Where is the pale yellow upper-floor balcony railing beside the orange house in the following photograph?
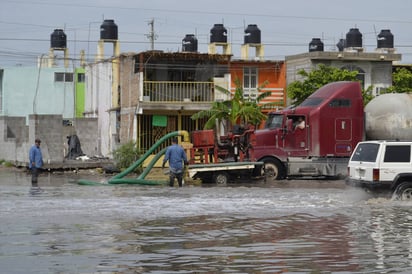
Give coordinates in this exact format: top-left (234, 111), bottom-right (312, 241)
top-left (143, 81), bottom-right (214, 103)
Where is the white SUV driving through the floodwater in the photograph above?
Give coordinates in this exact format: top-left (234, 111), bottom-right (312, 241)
top-left (347, 141), bottom-right (412, 200)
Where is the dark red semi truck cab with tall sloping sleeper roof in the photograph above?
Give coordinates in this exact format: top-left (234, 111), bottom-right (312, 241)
top-left (253, 81), bottom-right (364, 179)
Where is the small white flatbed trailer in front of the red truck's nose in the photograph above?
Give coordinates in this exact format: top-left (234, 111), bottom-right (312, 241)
top-left (187, 162), bottom-right (264, 185)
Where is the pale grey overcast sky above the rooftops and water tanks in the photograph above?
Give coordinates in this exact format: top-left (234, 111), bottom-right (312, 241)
top-left (0, 0), bottom-right (412, 67)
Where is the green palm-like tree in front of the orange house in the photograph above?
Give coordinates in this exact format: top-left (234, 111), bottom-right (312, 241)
top-left (191, 79), bottom-right (280, 129)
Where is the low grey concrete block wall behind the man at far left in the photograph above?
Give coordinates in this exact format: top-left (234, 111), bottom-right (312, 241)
top-left (0, 115), bottom-right (102, 167)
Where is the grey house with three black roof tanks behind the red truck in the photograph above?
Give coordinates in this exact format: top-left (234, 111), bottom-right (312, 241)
top-left (285, 28), bottom-right (401, 95)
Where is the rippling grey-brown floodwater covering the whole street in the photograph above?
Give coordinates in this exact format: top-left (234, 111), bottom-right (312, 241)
top-left (0, 170), bottom-right (412, 273)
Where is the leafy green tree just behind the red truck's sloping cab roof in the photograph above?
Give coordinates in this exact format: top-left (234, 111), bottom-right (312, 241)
top-left (287, 64), bottom-right (362, 105)
